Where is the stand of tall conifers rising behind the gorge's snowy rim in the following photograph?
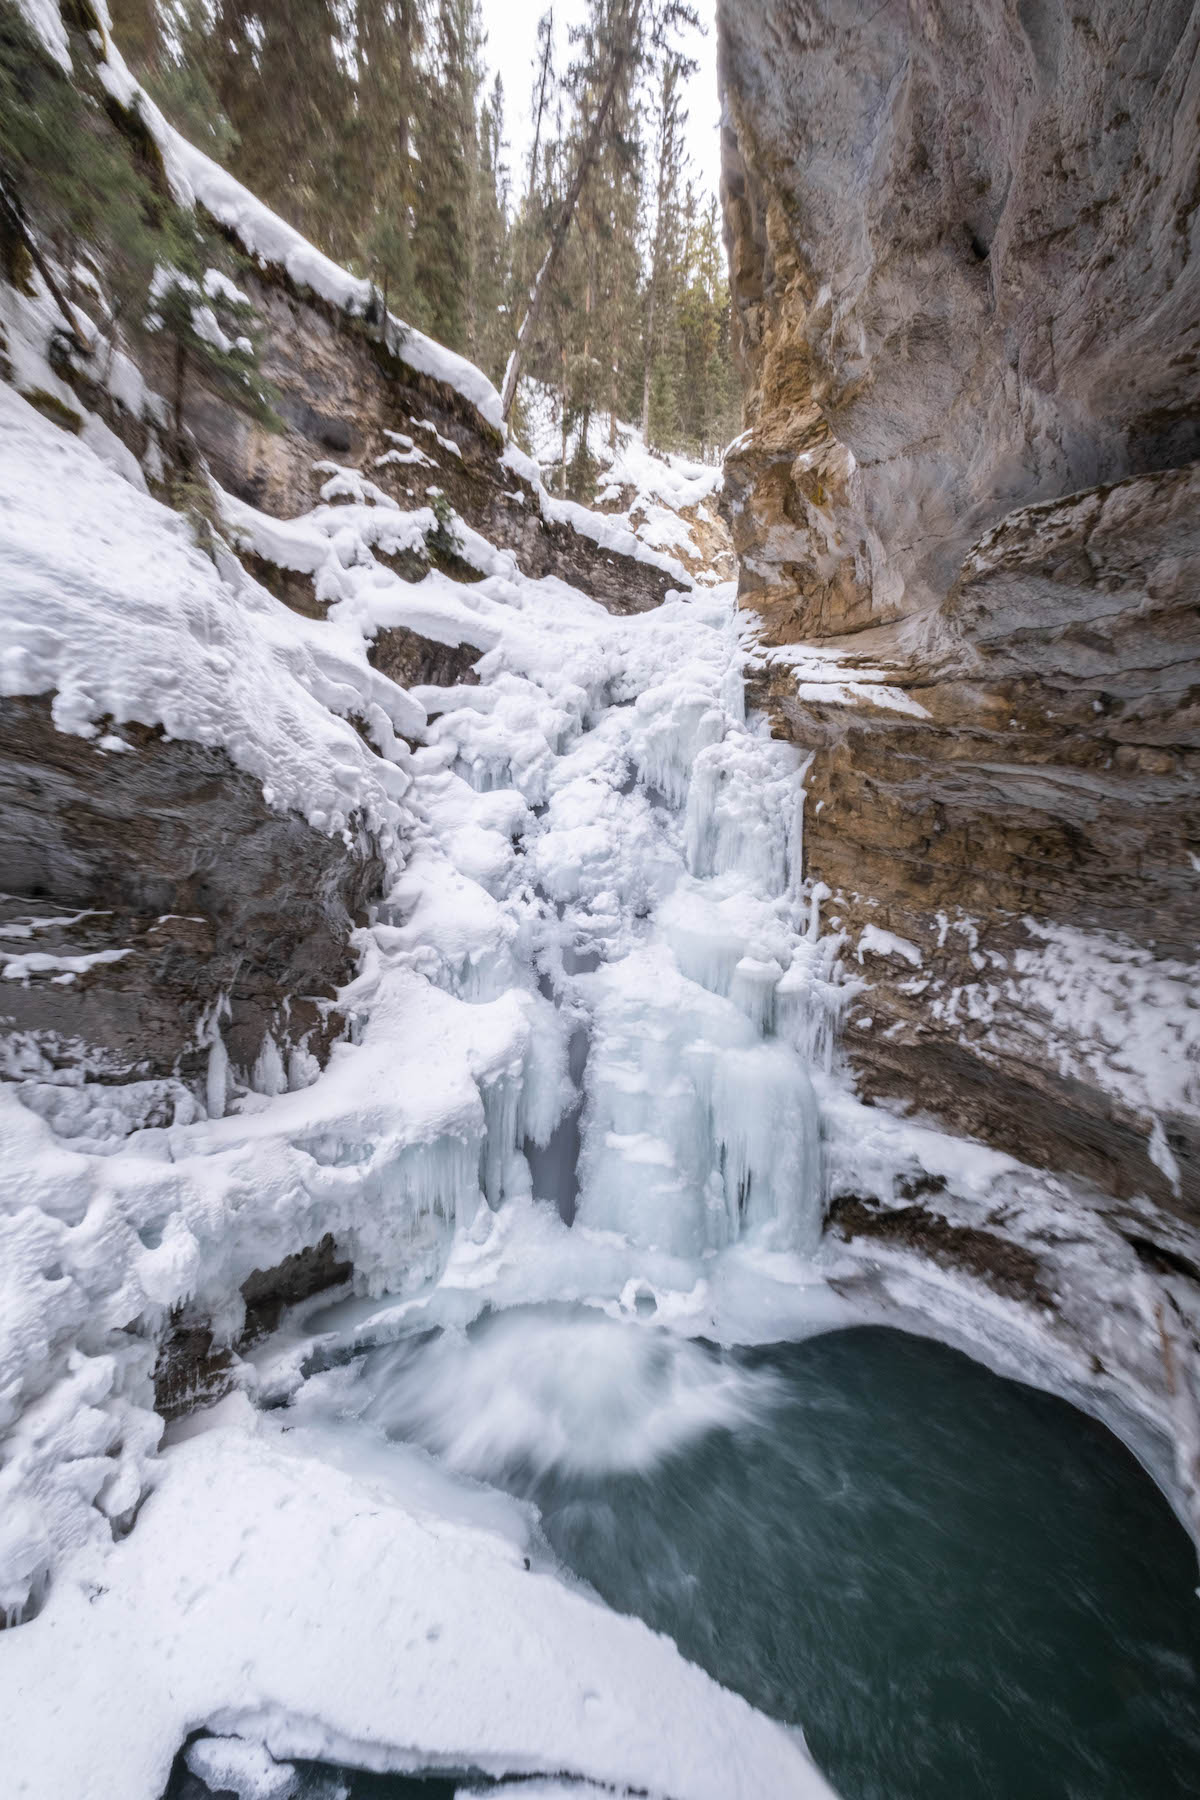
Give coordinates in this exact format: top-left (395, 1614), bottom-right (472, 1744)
top-left (98, 0), bottom-right (739, 471)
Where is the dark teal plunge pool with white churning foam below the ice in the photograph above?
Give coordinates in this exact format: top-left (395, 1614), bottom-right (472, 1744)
top-left (287, 1309), bottom-right (1200, 1800)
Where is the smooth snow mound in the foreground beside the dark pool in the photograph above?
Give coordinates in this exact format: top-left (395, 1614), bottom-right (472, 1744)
top-left (0, 1415), bottom-right (829, 1800)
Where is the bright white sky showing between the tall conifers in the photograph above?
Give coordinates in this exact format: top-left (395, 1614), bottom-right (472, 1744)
top-left (480, 0), bottom-right (721, 194)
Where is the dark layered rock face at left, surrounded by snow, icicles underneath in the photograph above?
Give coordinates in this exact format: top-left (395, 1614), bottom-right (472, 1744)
top-left (0, 698), bottom-right (381, 1136)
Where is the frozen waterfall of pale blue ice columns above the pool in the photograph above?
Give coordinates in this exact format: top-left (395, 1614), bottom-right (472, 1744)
top-left (415, 589), bottom-right (838, 1258)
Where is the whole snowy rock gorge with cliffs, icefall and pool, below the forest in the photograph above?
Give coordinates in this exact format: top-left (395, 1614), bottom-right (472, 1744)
top-left (0, 0), bottom-right (1200, 1800)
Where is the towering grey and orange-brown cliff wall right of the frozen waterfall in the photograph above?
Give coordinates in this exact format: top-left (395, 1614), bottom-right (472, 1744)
top-left (718, 0), bottom-right (1200, 1244)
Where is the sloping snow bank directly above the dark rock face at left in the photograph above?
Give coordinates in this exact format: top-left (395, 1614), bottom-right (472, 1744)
top-left (0, 385), bottom-right (425, 862)
